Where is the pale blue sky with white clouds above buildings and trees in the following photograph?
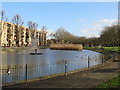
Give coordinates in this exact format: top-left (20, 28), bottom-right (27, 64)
top-left (1, 2), bottom-right (118, 37)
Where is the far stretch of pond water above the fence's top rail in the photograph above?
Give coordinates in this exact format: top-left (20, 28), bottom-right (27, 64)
top-left (2, 49), bottom-right (102, 65)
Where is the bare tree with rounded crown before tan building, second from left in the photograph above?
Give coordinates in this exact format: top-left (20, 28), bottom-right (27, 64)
top-left (12, 14), bottom-right (24, 47)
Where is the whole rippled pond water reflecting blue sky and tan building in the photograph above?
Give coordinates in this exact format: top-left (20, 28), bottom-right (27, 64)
top-left (1, 49), bottom-right (103, 84)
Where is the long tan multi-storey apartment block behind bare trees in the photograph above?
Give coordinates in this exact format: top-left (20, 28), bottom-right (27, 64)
top-left (0, 21), bottom-right (47, 46)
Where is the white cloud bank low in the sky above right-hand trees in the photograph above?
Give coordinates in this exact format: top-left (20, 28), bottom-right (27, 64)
top-left (81, 19), bottom-right (117, 38)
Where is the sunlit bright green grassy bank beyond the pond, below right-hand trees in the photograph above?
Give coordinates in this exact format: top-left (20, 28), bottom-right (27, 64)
top-left (84, 47), bottom-right (120, 52)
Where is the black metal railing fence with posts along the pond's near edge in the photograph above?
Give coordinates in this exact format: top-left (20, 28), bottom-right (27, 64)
top-left (0, 56), bottom-right (109, 86)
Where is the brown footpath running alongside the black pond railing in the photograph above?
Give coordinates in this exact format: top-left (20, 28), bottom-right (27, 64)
top-left (5, 61), bottom-right (120, 88)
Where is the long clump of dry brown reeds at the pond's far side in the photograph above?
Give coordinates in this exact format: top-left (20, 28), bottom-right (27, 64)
top-left (50, 44), bottom-right (83, 51)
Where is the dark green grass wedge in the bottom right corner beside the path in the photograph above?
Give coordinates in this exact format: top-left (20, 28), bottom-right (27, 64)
top-left (97, 76), bottom-right (120, 88)
